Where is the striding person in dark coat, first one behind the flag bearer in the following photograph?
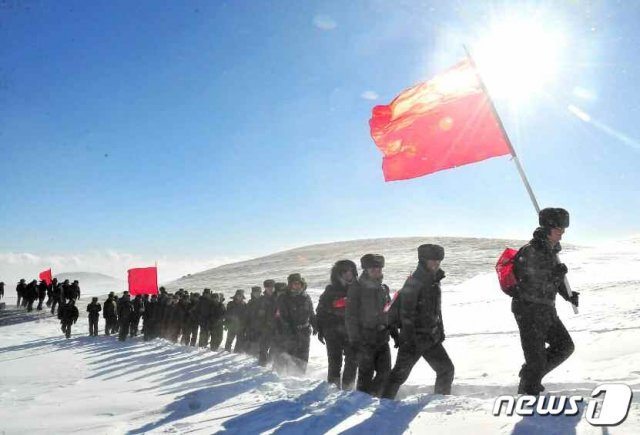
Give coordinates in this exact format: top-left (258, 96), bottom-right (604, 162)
top-left (382, 244), bottom-right (455, 399)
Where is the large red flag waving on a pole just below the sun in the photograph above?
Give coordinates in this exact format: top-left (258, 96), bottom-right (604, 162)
top-left (369, 59), bottom-right (510, 181)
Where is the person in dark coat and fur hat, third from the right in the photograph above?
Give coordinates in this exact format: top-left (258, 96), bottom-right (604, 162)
top-left (345, 254), bottom-right (391, 397)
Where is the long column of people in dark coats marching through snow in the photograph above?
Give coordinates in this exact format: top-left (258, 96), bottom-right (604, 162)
top-left (6, 208), bottom-right (578, 399)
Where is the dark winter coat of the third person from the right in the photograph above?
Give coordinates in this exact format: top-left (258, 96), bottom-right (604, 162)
top-left (345, 271), bottom-right (391, 344)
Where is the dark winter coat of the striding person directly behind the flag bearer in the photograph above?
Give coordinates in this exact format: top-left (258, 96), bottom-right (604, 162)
top-left (396, 263), bottom-right (444, 348)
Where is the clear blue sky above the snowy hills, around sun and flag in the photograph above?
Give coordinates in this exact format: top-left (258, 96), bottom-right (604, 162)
top-left (0, 0), bottom-right (640, 278)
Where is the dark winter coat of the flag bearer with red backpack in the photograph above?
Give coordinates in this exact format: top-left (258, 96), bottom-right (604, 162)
top-left (513, 228), bottom-right (568, 306)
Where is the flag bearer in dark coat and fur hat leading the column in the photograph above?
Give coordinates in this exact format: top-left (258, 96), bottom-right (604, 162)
top-left (511, 208), bottom-right (578, 395)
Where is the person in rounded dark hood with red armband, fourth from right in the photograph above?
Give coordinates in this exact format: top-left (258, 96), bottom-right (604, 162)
top-left (316, 260), bottom-right (358, 390)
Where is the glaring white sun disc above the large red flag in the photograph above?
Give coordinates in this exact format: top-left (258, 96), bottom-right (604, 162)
top-left (472, 18), bottom-right (564, 102)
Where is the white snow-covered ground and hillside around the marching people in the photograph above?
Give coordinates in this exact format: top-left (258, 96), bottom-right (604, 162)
top-left (0, 239), bottom-right (640, 434)
